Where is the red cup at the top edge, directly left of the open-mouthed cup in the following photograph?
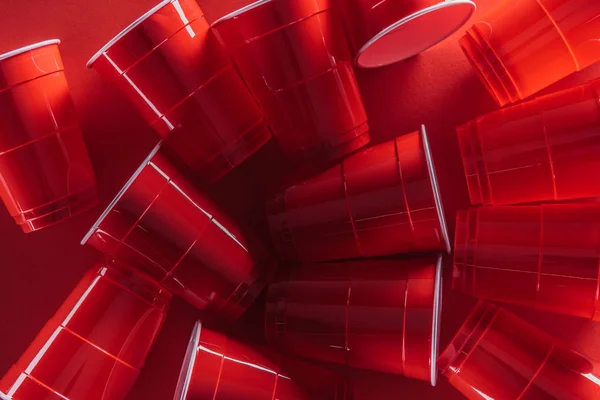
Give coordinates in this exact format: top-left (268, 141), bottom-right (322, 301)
top-left (213, 0), bottom-right (370, 165)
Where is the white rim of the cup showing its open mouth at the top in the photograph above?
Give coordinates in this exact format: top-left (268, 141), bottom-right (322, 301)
top-left (354, 0), bottom-right (477, 68)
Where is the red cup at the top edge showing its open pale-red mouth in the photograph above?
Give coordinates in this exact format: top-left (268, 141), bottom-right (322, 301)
top-left (340, 0), bottom-right (475, 68)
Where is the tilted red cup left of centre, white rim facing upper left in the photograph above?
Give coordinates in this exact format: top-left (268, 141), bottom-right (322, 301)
top-left (81, 144), bottom-right (275, 319)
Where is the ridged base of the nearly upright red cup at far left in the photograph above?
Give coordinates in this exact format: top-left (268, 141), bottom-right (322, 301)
top-left (15, 186), bottom-right (98, 233)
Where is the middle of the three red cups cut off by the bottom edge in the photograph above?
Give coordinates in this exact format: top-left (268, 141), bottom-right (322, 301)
top-left (173, 322), bottom-right (354, 400)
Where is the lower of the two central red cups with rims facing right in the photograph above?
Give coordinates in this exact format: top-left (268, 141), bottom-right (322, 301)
top-left (265, 256), bottom-right (442, 386)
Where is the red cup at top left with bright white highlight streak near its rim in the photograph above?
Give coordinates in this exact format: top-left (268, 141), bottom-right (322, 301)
top-left (88, 0), bottom-right (271, 181)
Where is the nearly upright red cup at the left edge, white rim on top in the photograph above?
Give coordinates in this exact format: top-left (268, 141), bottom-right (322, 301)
top-left (0, 39), bottom-right (97, 233)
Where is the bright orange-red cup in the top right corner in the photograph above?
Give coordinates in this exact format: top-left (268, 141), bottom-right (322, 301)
top-left (459, 0), bottom-right (600, 106)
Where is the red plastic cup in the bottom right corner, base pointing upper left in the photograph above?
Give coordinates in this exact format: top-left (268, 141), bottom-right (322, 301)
top-left (439, 301), bottom-right (600, 400)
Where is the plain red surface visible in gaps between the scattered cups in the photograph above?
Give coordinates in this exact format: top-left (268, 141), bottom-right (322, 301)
top-left (0, 0), bottom-right (600, 400)
